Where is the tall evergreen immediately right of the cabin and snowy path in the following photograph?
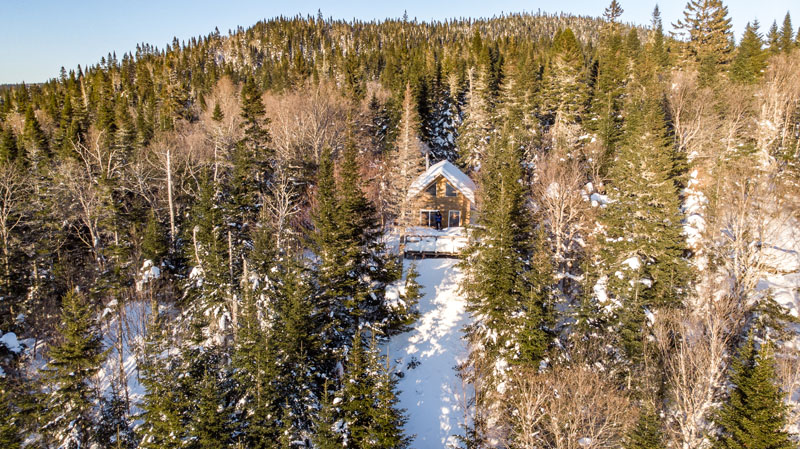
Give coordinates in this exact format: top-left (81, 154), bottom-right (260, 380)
top-left (463, 120), bottom-right (552, 372)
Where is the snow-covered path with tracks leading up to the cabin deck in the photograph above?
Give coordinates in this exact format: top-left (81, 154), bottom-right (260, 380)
top-left (387, 259), bottom-right (469, 449)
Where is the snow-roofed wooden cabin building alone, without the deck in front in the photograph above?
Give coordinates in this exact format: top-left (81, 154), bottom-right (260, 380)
top-left (408, 161), bottom-right (476, 228)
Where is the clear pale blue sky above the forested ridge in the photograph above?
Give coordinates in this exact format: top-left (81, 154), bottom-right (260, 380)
top-left (0, 0), bottom-right (800, 84)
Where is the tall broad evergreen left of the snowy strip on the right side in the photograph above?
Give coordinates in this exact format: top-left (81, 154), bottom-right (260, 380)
top-left (601, 54), bottom-right (689, 372)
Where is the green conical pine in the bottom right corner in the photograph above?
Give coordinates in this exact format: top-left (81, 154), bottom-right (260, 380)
top-left (714, 336), bottom-right (797, 449)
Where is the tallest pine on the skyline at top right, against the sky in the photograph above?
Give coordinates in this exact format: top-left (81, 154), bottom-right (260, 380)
top-left (675, 0), bottom-right (733, 85)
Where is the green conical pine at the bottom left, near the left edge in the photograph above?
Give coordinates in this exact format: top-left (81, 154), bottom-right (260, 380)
top-left (44, 290), bottom-right (105, 447)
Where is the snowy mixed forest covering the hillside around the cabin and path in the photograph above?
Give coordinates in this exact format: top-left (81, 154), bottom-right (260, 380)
top-left (0, 0), bottom-right (800, 449)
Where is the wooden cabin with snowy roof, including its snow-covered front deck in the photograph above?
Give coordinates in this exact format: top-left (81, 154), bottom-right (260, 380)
top-left (400, 161), bottom-right (476, 257)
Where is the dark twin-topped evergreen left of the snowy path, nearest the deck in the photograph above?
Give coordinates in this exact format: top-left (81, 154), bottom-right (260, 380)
top-left (314, 141), bottom-right (400, 368)
